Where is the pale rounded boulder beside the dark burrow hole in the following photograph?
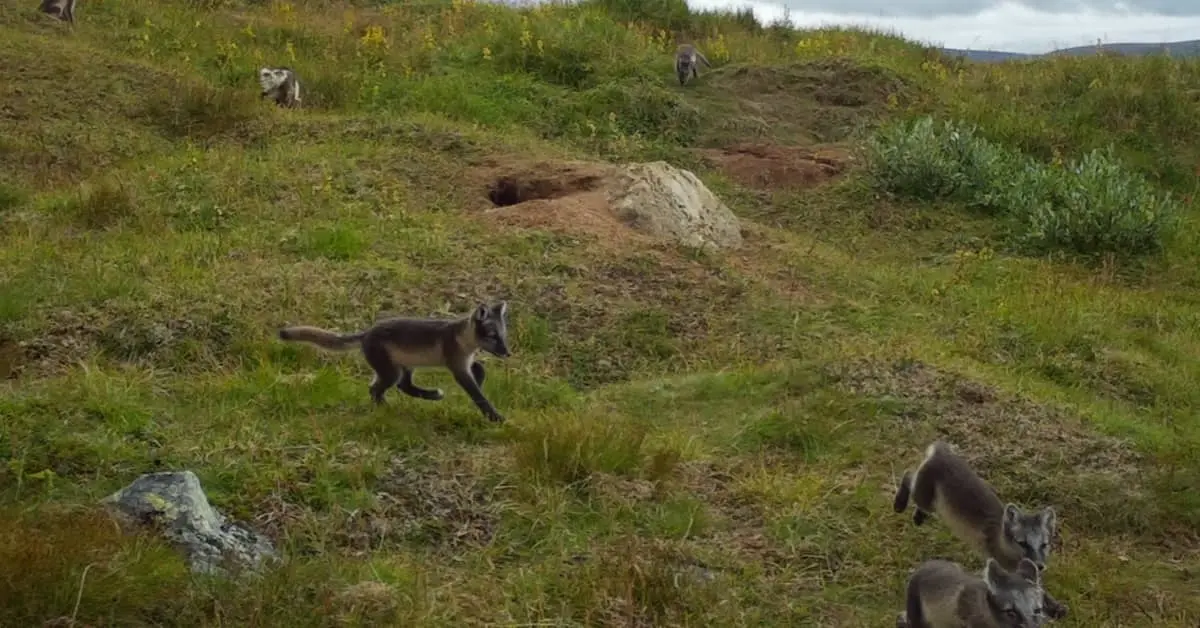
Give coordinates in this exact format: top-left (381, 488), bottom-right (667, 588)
top-left (608, 161), bottom-right (742, 249)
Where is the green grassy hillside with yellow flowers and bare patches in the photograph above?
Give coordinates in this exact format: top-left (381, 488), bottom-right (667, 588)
top-left (0, 0), bottom-right (1200, 627)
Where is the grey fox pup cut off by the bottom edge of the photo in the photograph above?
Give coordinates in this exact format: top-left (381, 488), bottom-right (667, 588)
top-left (896, 558), bottom-right (1046, 628)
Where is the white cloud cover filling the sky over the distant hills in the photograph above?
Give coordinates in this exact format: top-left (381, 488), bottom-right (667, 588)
top-left (688, 0), bottom-right (1200, 53)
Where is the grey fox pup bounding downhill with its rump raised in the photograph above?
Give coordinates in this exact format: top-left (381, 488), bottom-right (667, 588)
top-left (892, 441), bottom-right (1067, 618)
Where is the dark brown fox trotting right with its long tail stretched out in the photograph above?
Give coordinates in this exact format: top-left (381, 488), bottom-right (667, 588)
top-left (280, 301), bottom-right (511, 423)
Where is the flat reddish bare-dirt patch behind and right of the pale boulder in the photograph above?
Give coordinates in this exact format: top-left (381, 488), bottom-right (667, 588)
top-left (696, 143), bottom-right (853, 189)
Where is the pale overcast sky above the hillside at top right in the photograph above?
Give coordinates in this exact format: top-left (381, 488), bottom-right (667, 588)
top-left (688, 0), bottom-right (1200, 53)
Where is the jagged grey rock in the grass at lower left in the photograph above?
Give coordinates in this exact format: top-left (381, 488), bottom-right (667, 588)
top-left (102, 471), bottom-right (277, 574)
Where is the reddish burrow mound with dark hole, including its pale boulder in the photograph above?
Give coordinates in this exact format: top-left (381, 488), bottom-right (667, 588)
top-left (484, 162), bottom-right (742, 249)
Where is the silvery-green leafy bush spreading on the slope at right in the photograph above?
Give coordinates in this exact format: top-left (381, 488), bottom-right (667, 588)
top-left (865, 116), bottom-right (1181, 255)
